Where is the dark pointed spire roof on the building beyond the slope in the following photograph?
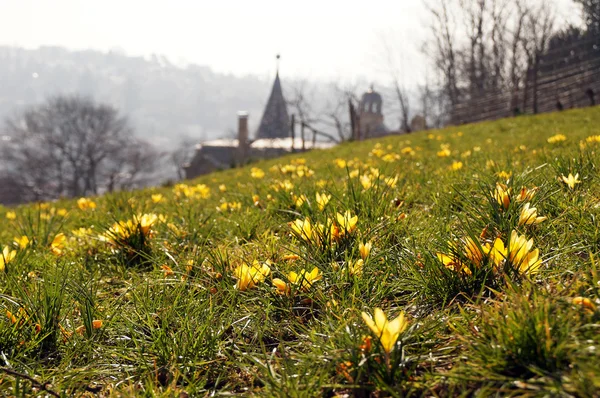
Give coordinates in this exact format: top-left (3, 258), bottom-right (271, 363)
top-left (256, 71), bottom-right (290, 139)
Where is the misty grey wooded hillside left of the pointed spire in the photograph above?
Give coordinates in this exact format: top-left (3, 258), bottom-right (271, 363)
top-left (0, 46), bottom-right (272, 147)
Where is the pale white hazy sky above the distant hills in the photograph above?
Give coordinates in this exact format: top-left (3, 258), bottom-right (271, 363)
top-left (0, 0), bottom-right (577, 84)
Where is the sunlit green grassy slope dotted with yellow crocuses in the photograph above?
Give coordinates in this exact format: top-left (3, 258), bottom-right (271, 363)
top-left (0, 107), bottom-right (600, 397)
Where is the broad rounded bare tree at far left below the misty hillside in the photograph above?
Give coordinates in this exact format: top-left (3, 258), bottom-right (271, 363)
top-left (2, 96), bottom-right (156, 200)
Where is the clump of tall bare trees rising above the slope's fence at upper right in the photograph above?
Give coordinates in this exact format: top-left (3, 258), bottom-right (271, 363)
top-left (425, 0), bottom-right (560, 121)
